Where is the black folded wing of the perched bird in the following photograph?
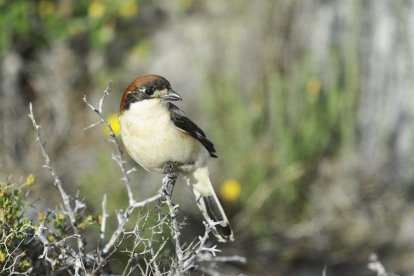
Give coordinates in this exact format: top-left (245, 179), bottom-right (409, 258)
top-left (168, 103), bottom-right (217, 158)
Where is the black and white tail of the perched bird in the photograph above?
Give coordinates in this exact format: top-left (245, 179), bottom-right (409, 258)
top-left (186, 167), bottom-right (234, 242)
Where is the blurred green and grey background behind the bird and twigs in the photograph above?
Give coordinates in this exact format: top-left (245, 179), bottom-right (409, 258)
top-left (0, 0), bottom-right (414, 275)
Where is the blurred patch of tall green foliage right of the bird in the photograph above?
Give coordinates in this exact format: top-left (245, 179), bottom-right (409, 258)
top-left (203, 53), bottom-right (358, 236)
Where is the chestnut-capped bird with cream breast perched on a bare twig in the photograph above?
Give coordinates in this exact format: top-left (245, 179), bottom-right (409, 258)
top-left (119, 74), bottom-right (234, 242)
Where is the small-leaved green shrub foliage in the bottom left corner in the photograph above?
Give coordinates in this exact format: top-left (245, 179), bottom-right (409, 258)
top-left (0, 177), bottom-right (99, 275)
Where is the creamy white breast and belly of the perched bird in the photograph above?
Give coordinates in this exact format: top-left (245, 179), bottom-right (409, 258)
top-left (119, 99), bottom-right (208, 171)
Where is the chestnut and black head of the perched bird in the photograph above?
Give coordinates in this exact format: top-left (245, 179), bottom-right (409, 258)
top-left (119, 75), bottom-right (182, 113)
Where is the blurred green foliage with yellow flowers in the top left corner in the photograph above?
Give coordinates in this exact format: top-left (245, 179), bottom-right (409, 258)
top-left (0, 0), bottom-right (145, 56)
